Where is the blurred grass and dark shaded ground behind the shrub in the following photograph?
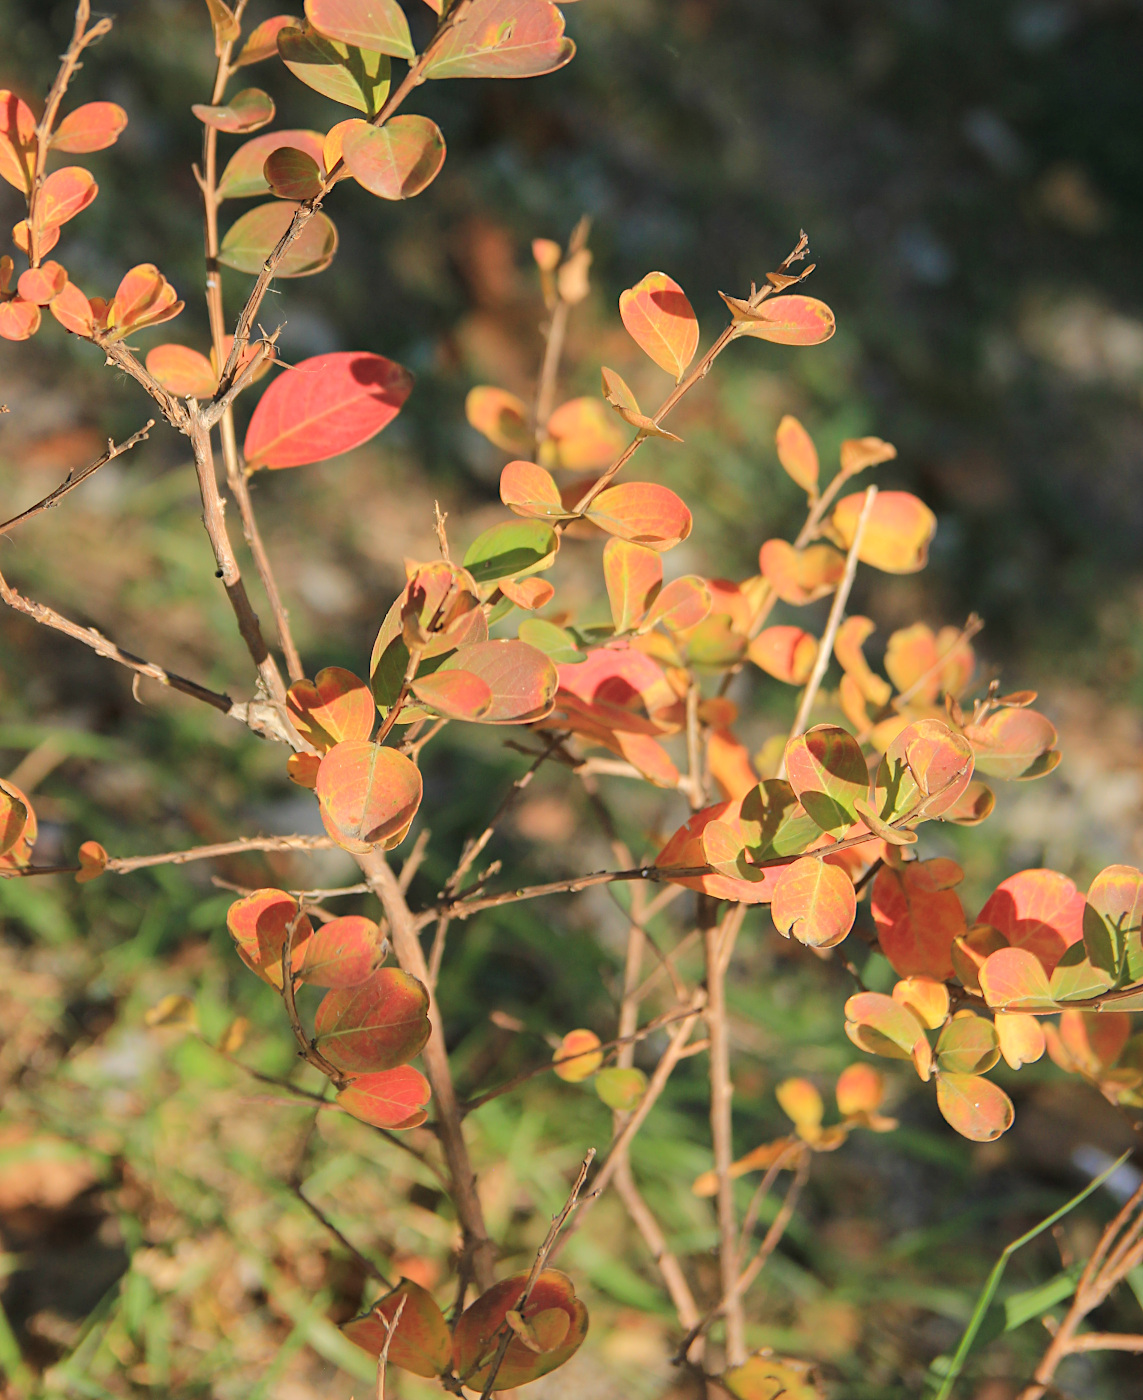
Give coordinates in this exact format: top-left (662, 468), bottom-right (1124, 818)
top-left (0, 0), bottom-right (1143, 1400)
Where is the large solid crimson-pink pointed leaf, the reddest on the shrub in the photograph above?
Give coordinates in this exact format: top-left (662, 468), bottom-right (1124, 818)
top-left (244, 350), bottom-right (413, 470)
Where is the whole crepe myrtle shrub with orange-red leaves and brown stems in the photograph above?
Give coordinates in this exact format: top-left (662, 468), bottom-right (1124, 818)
top-left (0, 0), bottom-right (1143, 1400)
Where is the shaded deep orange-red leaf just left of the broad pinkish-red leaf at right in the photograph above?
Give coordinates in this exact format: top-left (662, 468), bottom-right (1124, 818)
top-left (870, 861), bottom-right (965, 981)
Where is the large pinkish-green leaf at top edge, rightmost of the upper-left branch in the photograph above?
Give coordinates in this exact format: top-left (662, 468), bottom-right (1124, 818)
top-left (424, 0), bottom-right (576, 81)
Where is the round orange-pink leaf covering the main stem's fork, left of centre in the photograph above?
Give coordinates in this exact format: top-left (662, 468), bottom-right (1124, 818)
top-left (315, 739), bottom-right (422, 855)
